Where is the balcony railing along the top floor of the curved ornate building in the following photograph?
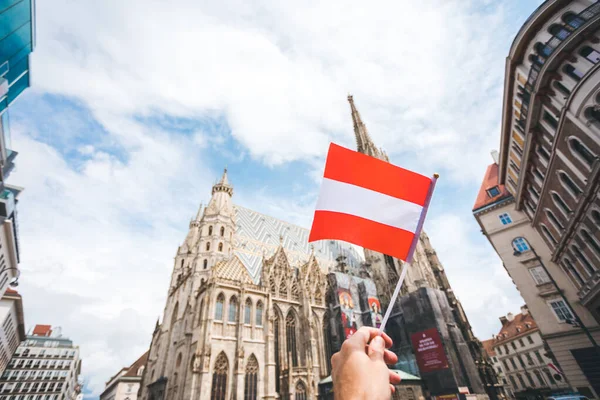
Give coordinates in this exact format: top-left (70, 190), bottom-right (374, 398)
top-left (517, 1), bottom-right (600, 134)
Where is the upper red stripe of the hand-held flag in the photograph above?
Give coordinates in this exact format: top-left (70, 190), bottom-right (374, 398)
top-left (324, 143), bottom-right (431, 206)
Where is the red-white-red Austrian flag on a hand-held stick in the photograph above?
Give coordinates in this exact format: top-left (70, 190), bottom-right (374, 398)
top-left (308, 143), bottom-right (435, 262)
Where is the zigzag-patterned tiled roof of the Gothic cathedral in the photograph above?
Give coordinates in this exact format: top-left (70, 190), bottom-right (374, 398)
top-left (233, 205), bottom-right (364, 283)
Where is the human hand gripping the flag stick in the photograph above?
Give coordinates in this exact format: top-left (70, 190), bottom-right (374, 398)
top-left (331, 326), bottom-right (400, 400)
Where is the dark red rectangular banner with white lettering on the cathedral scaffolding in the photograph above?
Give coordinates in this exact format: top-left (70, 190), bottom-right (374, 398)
top-left (410, 328), bottom-right (448, 373)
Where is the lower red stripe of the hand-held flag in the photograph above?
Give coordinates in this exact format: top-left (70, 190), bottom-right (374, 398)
top-left (308, 211), bottom-right (415, 260)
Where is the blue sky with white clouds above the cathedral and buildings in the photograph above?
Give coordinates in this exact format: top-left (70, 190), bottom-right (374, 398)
top-left (10, 0), bottom-right (540, 398)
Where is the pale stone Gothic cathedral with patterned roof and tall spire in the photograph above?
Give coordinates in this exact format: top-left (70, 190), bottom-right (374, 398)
top-left (140, 96), bottom-right (492, 400)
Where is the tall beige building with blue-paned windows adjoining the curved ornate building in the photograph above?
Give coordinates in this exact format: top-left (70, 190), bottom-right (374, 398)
top-left (473, 158), bottom-right (600, 397)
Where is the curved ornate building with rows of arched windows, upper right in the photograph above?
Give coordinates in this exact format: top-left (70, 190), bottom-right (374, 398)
top-left (499, 0), bottom-right (600, 321)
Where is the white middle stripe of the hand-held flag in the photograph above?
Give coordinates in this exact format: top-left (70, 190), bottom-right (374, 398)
top-left (316, 178), bottom-right (423, 232)
